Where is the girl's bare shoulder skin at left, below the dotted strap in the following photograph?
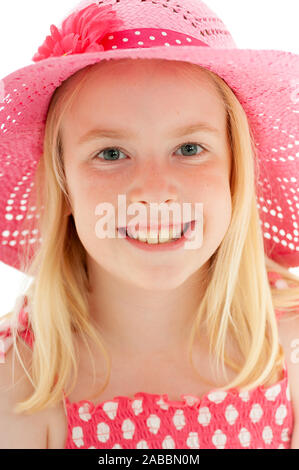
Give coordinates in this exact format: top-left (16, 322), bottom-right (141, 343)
top-left (0, 339), bottom-right (49, 449)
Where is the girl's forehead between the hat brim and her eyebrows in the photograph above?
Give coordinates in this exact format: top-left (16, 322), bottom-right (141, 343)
top-left (64, 60), bottom-right (226, 133)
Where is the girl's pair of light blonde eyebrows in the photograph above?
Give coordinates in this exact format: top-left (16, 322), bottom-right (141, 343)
top-left (78, 122), bottom-right (220, 144)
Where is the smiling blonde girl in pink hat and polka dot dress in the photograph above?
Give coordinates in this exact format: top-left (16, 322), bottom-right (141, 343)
top-left (0, 0), bottom-right (299, 449)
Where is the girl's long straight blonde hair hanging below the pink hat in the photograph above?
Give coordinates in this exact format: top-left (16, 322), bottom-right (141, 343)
top-left (4, 59), bottom-right (299, 414)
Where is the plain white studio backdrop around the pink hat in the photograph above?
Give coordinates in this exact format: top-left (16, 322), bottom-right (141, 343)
top-left (0, 0), bottom-right (299, 317)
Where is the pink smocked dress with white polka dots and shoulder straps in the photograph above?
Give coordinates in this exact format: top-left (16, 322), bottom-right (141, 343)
top-left (0, 273), bottom-right (294, 449)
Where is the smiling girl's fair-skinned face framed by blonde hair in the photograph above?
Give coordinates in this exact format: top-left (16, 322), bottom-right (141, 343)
top-left (62, 61), bottom-right (231, 289)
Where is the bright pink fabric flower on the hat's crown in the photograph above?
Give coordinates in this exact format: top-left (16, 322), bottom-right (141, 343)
top-left (32, 3), bottom-right (123, 62)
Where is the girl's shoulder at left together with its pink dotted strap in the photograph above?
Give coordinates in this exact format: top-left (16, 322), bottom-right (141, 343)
top-left (0, 302), bottom-right (55, 449)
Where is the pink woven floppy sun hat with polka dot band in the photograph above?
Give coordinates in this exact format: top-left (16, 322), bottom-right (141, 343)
top-left (0, 0), bottom-right (299, 270)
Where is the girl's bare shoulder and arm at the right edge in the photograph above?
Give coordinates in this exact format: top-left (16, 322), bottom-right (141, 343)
top-left (278, 313), bottom-right (299, 449)
